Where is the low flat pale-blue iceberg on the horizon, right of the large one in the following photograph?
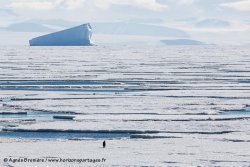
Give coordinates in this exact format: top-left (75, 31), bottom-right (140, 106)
top-left (161, 39), bottom-right (205, 45)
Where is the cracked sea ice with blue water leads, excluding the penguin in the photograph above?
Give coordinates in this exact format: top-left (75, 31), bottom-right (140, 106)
top-left (0, 45), bottom-right (250, 167)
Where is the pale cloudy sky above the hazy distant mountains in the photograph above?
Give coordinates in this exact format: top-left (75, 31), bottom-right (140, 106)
top-left (0, 0), bottom-right (250, 44)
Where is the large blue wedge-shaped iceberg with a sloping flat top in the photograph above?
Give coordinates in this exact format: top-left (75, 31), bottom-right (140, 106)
top-left (29, 23), bottom-right (92, 46)
